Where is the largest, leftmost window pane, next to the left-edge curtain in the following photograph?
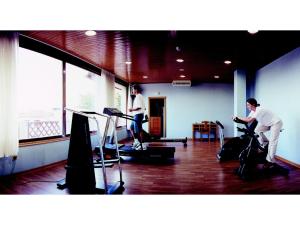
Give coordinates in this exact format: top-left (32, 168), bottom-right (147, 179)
top-left (18, 48), bottom-right (62, 139)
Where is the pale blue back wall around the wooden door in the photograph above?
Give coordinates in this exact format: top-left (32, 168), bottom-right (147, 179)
top-left (142, 83), bottom-right (234, 138)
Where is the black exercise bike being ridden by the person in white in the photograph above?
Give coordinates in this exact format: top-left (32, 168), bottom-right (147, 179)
top-left (234, 118), bottom-right (289, 180)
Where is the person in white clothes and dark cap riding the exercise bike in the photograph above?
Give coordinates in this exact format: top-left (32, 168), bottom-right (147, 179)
top-left (233, 98), bottom-right (283, 168)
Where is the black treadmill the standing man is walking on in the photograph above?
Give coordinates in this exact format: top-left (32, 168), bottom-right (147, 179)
top-left (97, 108), bottom-right (176, 159)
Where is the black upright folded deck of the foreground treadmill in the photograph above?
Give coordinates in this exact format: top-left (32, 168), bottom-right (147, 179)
top-left (66, 113), bottom-right (96, 194)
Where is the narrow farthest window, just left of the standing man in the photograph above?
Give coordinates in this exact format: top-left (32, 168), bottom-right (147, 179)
top-left (114, 83), bottom-right (127, 127)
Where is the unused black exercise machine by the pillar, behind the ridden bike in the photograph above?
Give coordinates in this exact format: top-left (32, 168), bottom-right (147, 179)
top-left (216, 120), bottom-right (257, 162)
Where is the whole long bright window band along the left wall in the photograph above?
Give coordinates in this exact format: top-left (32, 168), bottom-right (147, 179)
top-left (17, 44), bottom-right (127, 140)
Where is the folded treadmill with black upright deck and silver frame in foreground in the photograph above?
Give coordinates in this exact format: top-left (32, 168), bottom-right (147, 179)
top-left (57, 109), bottom-right (124, 194)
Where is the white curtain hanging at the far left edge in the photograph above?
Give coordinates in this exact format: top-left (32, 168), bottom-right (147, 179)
top-left (0, 32), bottom-right (19, 158)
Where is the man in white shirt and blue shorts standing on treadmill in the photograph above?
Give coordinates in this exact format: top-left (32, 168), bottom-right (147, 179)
top-left (128, 85), bottom-right (146, 150)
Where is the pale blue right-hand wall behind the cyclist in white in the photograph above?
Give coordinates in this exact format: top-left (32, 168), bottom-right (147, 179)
top-left (254, 48), bottom-right (300, 164)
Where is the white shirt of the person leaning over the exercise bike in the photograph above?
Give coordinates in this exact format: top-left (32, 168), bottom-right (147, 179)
top-left (248, 106), bottom-right (281, 127)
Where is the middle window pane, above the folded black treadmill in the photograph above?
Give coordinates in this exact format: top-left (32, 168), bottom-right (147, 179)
top-left (66, 63), bottom-right (102, 134)
